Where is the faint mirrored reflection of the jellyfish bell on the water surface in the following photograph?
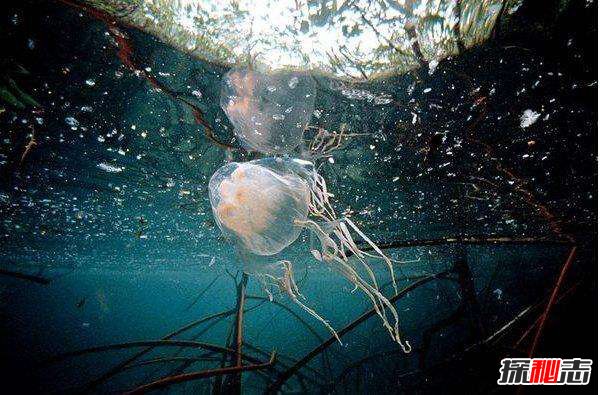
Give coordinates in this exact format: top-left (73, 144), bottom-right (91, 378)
top-left (221, 69), bottom-right (315, 154)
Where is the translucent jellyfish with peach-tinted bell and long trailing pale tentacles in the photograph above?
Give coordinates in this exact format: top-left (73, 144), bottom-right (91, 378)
top-left (209, 158), bottom-right (410, 352)
